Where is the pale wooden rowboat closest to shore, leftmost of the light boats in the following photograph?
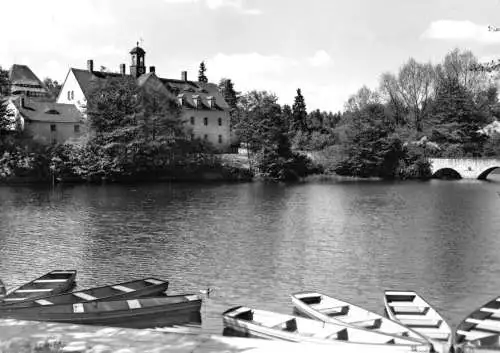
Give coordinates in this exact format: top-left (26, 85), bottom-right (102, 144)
top-left (223, 306), bottom-right (431, 352)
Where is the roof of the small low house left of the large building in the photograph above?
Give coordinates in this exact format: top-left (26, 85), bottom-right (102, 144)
top-left (12, 97), bottom-right (83, 123)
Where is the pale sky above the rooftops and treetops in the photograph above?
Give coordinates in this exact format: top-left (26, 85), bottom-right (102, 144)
top-left (4, 0), bottom-right (500, 112)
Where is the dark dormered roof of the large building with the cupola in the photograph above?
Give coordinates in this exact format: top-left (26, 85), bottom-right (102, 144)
top-left (70, 68), bottom-right (229, 110)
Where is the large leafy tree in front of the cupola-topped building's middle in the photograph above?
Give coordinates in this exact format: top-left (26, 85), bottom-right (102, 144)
top-left (83, 76), bottom-right (188, 177)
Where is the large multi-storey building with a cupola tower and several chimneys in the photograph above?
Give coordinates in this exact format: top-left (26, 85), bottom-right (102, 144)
top-left (57, 46), bottom-right (231, 151)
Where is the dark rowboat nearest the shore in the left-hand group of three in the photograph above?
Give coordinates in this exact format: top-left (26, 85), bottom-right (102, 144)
top-left (0, 294), bottom-right (202, 328)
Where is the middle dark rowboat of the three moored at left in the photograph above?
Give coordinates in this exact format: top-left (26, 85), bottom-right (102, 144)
top-left (0, 278), bottom-right (168, 310)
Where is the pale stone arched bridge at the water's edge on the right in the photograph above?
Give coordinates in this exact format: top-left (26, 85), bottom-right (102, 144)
top-left (429, 158), bottom-right (500, 179)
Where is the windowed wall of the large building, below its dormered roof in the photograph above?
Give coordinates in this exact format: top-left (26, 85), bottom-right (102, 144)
top-left (182, 109), bottom-right (231, 151)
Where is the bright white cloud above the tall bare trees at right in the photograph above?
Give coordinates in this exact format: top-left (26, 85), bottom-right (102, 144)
top-left (421, 20), bottom-right (500, 44)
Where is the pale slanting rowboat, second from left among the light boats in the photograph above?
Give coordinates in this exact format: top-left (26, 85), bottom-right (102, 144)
top-left (291, 292), bottom-right (428, 343)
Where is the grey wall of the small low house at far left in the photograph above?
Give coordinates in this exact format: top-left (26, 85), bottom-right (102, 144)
top-left (25, 121), bottom-right (86, 144)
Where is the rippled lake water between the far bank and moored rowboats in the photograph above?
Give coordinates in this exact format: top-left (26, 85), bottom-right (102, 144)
top-left (0, 175), bottom-right (500, 333)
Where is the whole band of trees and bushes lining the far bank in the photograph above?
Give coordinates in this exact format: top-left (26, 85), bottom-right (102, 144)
top-left (0, 49), bottom-right (500, 181)
